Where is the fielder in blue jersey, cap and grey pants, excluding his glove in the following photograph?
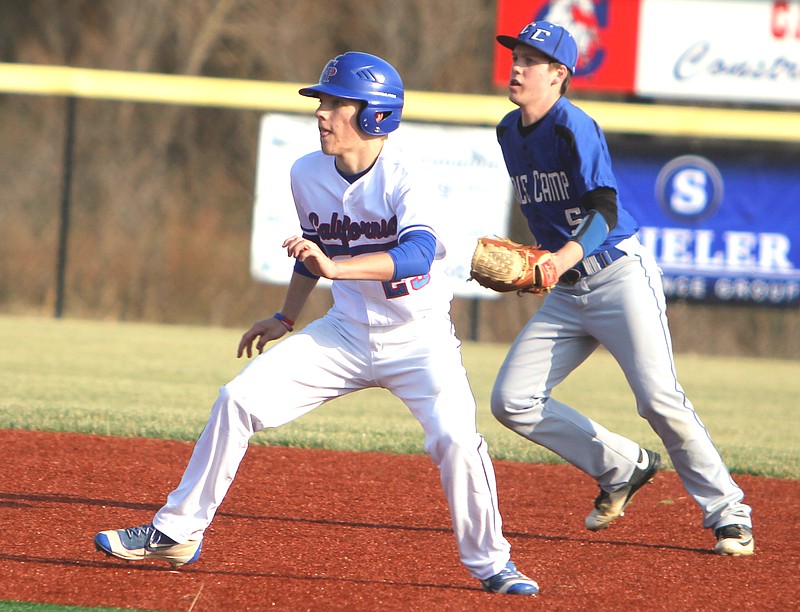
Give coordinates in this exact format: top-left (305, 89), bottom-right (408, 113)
top-left (491, 21), bottom-right (754, 555)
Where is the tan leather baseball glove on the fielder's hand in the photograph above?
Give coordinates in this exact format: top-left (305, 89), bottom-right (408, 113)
top-left (470, 236), bottom-right (558, 293)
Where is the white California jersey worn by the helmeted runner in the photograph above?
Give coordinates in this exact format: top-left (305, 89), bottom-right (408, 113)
top-left (291, 140), bottom-right (453, 326)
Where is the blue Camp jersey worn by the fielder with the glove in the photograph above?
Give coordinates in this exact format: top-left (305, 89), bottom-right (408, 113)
top-left (497, 97), bottom-right (639, 255)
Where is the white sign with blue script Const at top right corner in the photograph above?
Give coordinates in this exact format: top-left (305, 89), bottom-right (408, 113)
top-left (635, 0), bottom-right (800, 106)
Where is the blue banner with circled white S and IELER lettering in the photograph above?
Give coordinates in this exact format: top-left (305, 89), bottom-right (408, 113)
top-left (614, 148), bottom-right (800, 306)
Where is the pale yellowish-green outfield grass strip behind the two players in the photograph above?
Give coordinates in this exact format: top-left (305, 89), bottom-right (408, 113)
top-left (0, 316), bottom-right (800, 478)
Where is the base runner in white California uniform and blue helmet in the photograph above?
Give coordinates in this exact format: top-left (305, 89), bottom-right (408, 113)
top-left (94, 52), bottom-right (539, 595)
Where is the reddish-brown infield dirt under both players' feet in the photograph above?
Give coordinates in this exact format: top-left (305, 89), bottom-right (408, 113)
top-left (0, 430), bottom-right (800, 612)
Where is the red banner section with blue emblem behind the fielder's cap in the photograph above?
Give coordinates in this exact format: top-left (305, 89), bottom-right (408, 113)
top-left (493, 0), bottom-right (640, 93)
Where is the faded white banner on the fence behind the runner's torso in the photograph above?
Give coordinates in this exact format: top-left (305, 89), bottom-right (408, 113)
top-left (250, 113), bottom-right (512, 298)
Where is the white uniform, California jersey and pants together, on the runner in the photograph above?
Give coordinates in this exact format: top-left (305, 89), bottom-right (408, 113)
top-left (153, 136), bottom-right (511, 580)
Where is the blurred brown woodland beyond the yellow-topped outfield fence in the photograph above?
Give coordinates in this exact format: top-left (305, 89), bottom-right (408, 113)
top-left (0, 0), bottom-right (800, 356)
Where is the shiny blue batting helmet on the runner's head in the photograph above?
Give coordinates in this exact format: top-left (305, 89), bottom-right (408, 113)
top-left (300, 51), bottom-right (403, 136)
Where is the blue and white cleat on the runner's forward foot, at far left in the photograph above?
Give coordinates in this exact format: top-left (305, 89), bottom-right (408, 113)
top-left (94, 525), bottom-right (202, 569)
